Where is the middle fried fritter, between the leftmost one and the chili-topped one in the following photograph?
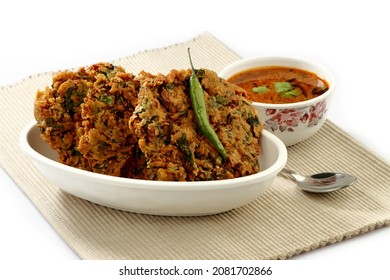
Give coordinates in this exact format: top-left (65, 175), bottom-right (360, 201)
top-left (78, 63), bottom-right (139, 177)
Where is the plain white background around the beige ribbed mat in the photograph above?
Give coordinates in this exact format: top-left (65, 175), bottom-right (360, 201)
top-left (0, 0), bottom-right (390, 265)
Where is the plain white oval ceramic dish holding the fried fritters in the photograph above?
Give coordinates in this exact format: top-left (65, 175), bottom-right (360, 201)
top-left (20, 122), bottom-right (287, 216)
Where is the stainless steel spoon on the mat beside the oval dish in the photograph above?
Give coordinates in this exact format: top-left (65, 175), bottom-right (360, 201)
top-left (281, 168), bottom-right (357, 193)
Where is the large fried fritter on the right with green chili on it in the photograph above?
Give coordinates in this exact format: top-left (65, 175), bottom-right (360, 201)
top-left (129, 69), bottom-right (263, 181)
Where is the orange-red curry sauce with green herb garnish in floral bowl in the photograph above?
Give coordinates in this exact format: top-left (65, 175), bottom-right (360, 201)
top-left (228, 66), bottom-right (329, 104)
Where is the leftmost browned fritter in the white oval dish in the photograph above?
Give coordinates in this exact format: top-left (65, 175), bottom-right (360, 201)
top-left (34, 71), bottom-right (89, 170)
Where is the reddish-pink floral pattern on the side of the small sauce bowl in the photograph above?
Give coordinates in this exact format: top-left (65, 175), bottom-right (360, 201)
top-left (264, 99), bottom-right (328, 132)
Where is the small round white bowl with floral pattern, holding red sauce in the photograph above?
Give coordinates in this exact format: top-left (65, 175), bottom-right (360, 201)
top-left (219, 56), bottom-right (335, 146)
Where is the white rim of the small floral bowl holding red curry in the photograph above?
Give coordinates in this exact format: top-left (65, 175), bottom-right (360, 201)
top-left (218, 56), bottom-right (335, 109)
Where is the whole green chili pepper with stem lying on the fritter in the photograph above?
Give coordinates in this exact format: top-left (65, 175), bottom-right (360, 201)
top-left (188, 48), bottom-right (227, 162)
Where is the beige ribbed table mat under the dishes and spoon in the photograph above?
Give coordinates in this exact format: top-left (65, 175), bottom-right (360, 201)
top-left (0, 33), bottom-right (390, 259)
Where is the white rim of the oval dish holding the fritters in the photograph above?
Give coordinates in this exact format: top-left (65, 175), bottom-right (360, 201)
top-left (19, 121), bottom-right (287, 191)
